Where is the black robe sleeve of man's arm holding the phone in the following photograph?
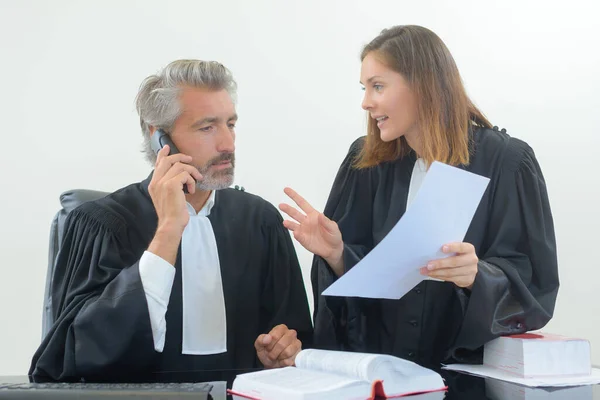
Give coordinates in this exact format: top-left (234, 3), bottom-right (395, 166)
top-left (29, 204), bottom-right (156, 381)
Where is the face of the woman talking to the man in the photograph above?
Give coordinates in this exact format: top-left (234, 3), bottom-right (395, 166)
top-left (360, 52), bottom-right (417, 144)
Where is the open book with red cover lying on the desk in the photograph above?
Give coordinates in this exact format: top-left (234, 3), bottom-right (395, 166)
top-left (229, 349), bottom-right (447, 400)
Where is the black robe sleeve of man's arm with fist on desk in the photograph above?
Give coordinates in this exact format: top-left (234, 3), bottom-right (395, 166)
top-left (259, 204), bottom-right (313, 352)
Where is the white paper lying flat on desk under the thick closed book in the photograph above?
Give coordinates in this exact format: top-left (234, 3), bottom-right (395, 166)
top-left (442, 364), bottom-right (600, 387)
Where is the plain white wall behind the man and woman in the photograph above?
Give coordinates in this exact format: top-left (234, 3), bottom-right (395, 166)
top-left (0, 0), bottom-right (600, 375)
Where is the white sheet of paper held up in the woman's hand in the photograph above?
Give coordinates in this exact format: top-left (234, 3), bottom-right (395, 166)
top-left (323, 162), bottom-right (489, 299)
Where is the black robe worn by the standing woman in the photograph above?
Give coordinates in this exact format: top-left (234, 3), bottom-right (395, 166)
top-left (311, 128), bottom-right (559, 367)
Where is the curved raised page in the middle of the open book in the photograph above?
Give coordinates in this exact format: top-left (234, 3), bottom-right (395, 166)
top-left (296, 349), bottom-right (380, 382)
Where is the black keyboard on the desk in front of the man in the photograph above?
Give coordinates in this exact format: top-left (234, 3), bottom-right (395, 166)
top-left (0, 382), bottom-right (213, 400)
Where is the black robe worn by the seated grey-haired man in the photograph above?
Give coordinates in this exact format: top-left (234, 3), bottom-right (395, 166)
top-left (29, 178), bottom-right (312, 382)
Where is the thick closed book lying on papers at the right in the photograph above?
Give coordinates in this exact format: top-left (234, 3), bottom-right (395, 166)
top-left (483, 332), bottom-right (592, 378)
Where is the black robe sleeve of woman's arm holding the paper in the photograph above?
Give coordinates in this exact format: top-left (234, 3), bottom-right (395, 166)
top-left (452, 139), bottom-right (559, 362)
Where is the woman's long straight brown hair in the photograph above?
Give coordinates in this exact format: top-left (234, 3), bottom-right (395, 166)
top-left (355, 25), bottom-right (491, 168)
